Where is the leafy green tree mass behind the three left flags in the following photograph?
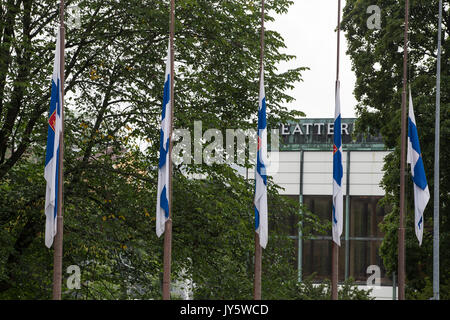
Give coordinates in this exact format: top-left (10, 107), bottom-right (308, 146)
top-left (0, 0), bottom-right (326, 299)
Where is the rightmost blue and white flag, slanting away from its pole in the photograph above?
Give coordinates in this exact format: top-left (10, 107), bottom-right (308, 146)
top-left (407, 90), bottom-right (430, 245)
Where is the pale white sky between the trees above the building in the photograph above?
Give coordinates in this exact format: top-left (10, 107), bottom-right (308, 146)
top-left (266, 0), bottom-right (357, 118)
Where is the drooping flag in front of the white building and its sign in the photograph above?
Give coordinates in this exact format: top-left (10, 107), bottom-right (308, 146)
top-left (332, 81), bottom-right (344, 246)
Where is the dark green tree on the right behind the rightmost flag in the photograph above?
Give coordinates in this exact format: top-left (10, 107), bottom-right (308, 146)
top-left (342, 0), bottom-right (450, 299)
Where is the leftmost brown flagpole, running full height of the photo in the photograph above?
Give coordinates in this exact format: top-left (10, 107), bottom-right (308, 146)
top-left (53, 0), bottom-right (65, 300)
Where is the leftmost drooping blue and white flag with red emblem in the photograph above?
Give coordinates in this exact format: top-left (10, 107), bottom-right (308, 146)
top-left (44, 31), bottom-right (62, 248)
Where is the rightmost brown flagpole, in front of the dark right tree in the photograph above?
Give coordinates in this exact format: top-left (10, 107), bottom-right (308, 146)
top-left (398, 0), bottom-right (409, 300)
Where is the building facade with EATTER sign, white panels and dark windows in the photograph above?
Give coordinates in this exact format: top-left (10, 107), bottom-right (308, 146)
top-left (269, 118), bottom-right (392, 292)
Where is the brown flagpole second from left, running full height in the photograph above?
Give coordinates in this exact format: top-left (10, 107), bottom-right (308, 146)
top-left (162, 0), bottom-right (175, 300)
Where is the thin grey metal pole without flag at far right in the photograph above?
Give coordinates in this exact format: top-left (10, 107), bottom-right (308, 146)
top-left (433, 0), bottom-right (442, 300)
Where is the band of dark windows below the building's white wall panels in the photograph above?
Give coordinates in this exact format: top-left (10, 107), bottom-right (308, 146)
top-left (302, 196), bottom-right (392, 285)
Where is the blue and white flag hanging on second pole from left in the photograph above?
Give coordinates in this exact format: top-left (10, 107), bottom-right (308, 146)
top-left (156, 43), bottom-right (172, 237)
